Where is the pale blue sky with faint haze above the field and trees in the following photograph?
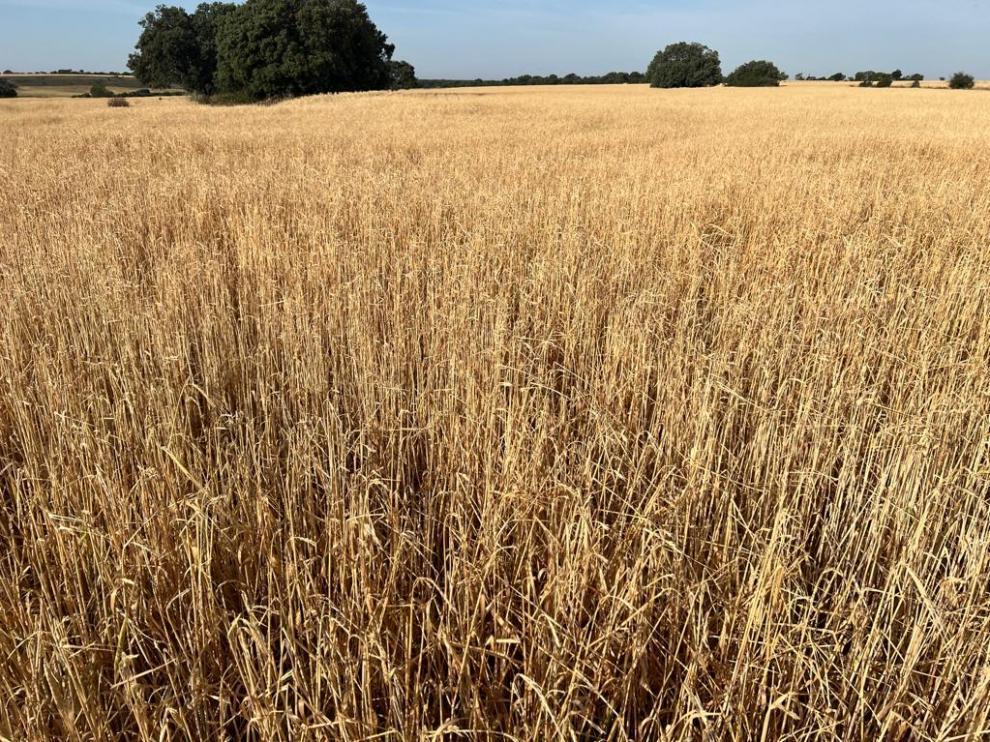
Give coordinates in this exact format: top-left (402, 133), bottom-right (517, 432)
top-left (0, 0), bottom-right (990, 79)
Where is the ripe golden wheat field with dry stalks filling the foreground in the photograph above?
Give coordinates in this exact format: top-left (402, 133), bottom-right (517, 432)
top-left (0, 86), bottom-right (990, 742)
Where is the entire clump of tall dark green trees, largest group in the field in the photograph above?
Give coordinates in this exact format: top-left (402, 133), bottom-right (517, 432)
top-left (128, 0), bottom-right (416, 101)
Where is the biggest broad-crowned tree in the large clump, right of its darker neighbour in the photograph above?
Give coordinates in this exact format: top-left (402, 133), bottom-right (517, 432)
top-left (217, 0), bottom-right (394, 100)
